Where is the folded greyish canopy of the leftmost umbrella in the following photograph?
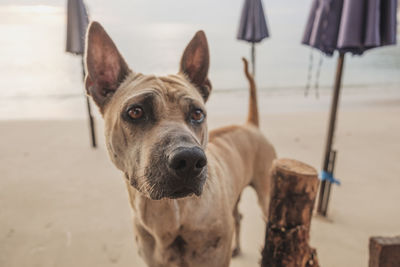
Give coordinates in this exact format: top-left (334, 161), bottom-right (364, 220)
top-left (66, 0), bottom-right (89, 55)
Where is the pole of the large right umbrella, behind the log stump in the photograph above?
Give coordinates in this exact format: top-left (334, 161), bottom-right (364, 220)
top-left (317, 53), bottom-right (345, 216)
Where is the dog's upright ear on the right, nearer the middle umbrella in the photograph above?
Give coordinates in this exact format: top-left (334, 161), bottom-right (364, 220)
top-left (180, 31), bottom-right (211, 101)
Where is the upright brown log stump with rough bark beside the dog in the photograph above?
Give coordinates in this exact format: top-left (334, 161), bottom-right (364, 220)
top-left (261, 159), bottom-right (319, 267)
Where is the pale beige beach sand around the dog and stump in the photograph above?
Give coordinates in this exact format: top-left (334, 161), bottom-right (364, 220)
top-left (0, 104), bottom-right (400, 267)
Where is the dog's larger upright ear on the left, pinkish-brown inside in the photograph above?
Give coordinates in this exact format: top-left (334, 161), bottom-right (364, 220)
top-left (85, 21), bottom-right (130, 113)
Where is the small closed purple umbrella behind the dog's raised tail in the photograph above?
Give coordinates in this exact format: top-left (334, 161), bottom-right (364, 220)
top-left (237, 0), bottom-right (269, 75)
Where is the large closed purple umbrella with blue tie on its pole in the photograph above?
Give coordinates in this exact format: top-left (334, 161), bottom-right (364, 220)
top-left (302, 0), bottom-right (397, 216)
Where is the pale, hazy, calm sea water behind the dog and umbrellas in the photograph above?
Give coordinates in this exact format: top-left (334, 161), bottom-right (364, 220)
top-left (0, 0), bottom-right (400, 119)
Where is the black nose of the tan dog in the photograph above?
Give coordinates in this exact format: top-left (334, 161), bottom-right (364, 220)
top-left (168, 147), bottom-right (207, 178)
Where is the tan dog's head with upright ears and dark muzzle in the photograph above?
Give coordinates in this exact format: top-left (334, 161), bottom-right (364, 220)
top-left (85, 22), bottom-right (211, 199)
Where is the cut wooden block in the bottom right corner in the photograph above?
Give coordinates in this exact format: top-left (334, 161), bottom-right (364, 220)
top-left (369, 236), bottom-right (400, 267)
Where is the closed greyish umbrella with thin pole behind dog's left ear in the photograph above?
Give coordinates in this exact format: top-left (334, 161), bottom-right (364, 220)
top-left (66, 0), bottom-right (96, 147)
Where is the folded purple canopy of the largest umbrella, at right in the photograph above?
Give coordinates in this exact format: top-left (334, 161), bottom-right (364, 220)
top-left (302, 0), bottom-right (397, 55)
